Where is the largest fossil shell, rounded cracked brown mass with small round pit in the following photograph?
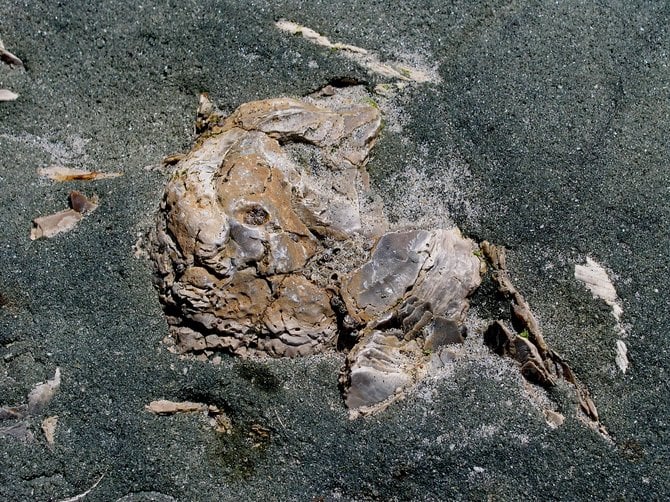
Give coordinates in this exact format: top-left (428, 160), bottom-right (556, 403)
top-left (150, 88), bottom-right (386, 356)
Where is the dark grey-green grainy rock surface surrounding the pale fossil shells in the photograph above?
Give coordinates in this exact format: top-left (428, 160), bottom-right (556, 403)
top-left (0, 0), bottom-right (670, 501)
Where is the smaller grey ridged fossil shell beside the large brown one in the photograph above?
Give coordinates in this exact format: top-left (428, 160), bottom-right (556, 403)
top-left (340, 228), bottom-right (481, 413)
